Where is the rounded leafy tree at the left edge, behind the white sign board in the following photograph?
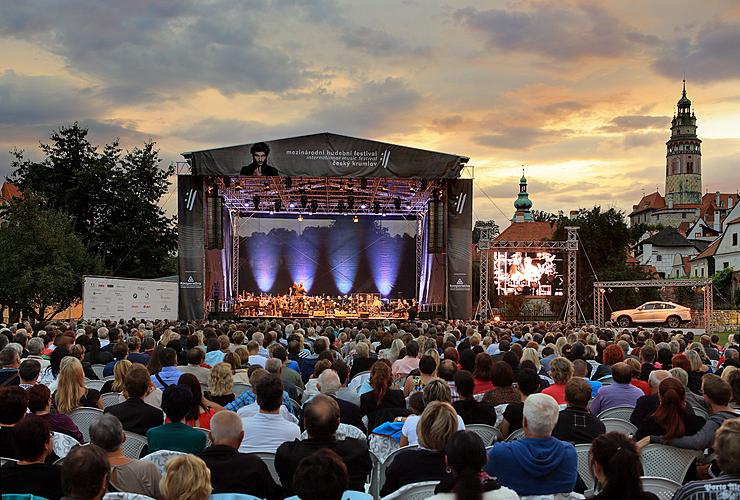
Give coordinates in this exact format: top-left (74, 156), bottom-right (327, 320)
top-left (0, 196), bottom-right (102, 320)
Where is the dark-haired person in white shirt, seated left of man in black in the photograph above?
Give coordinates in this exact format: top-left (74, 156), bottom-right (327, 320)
top-left (239, 374), bottom-right (301, 453)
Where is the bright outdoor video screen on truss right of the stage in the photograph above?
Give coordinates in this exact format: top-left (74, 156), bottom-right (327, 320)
top-left (491, 251), bottom-right (563, 296)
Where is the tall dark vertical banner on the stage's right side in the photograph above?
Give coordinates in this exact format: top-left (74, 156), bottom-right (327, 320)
top-left (447, 179), bottom-right (473, 319)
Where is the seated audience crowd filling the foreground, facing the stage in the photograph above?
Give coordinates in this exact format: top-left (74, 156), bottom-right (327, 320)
top-left (0, 319), bottom-right (740, 500)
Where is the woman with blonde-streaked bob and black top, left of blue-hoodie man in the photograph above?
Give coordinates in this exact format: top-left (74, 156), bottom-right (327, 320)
top-left (382, 400), bottom-right (456, 496)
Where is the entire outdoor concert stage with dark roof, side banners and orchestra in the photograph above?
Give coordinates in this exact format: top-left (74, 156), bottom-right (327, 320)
top-left (178, 133), bottom-right (473, 320)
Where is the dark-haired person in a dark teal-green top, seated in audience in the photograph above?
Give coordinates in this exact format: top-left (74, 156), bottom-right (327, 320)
top-left (146, 385), bottom-right (206, 454)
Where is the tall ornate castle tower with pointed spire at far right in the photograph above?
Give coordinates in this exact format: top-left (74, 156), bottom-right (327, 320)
top-left (665, 80), bottom-right (701, 208)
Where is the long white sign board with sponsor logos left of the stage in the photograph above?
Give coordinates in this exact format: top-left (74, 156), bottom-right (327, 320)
top-left (82, 276), bottom-right (178, 320)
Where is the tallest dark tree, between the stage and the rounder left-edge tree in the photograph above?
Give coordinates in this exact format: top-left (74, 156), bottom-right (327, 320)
top-left (12, 123), bottom-right (177, 278)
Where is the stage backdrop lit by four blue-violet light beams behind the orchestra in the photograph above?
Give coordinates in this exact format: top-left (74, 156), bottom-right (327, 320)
top-left (238, 215), bottom-right (416, 299)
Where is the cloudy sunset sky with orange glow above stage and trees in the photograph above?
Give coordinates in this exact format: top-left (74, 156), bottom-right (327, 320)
top-left (0, 0), bottom-right (740, 225)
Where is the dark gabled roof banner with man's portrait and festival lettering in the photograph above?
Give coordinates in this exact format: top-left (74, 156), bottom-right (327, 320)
top-left (183, 133), bottom-right (468, 179)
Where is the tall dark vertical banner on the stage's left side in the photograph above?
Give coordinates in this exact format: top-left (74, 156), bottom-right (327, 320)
top-left (177, 175), bottom-right (205, 320)
